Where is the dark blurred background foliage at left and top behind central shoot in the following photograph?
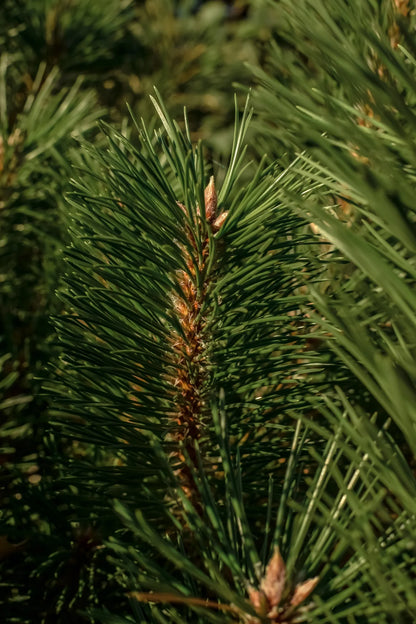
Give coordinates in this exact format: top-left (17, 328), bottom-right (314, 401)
top-left (0, 0), bottom-right (280, 622)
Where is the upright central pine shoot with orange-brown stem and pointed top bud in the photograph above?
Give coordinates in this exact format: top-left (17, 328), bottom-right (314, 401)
top-left (48, 95), bottom-right (324, 621)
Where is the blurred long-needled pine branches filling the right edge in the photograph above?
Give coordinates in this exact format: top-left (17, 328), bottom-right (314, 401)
top-left (250, 0), bottom-right (416, 622)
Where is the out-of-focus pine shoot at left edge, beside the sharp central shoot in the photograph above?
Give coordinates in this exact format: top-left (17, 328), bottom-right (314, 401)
top-left (0, 54), bottom-right (97, 600)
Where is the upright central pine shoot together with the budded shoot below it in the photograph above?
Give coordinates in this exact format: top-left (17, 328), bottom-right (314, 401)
top-left (47, 85), bottom-right (414, 624)
